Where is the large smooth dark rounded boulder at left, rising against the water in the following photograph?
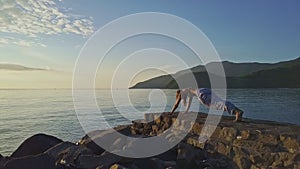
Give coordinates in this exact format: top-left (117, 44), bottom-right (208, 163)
top-left (10, 134), bottom-right (62, 158)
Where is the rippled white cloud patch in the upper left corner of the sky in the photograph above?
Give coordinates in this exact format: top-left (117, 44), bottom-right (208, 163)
top-left (0, 0), bottom-right (94, 36)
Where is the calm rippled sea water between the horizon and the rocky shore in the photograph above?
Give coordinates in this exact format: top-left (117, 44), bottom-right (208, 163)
top-left (0, 89), bottom-right (300, 155)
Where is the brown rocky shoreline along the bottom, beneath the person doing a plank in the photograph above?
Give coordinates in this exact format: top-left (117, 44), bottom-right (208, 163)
top-left (0, 113), bottom-right (300, 169)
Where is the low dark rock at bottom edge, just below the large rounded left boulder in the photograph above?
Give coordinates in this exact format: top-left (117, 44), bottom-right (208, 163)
top-left (3, 153), bottom-right (56, 169)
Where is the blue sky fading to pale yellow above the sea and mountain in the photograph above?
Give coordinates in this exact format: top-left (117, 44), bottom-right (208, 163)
top-left (0, 0), bottom-right (300, 88)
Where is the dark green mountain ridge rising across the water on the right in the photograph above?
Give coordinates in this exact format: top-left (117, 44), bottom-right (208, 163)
top-left (131, 58), bottom-right (300, 89)
